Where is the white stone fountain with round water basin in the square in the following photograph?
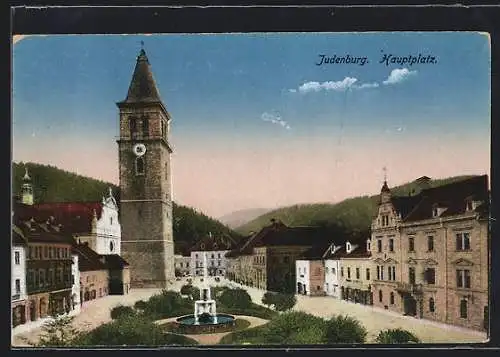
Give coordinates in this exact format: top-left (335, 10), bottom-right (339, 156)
top-left (176, 252), bottom-right (235, 333)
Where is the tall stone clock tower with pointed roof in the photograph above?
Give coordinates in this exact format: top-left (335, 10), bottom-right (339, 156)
top-left (117, 49), bottom-right (174, 288)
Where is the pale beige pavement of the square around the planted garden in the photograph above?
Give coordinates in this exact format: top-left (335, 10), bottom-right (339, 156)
top-left (12, 278), bottom-right (487, 346)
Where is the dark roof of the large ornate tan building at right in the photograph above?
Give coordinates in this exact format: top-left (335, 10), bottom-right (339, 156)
top-left (403, 175), bottom-right (489, 222)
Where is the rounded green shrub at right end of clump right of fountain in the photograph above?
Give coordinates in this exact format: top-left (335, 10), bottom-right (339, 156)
top-left (326, 315), bottom-right (367, 344)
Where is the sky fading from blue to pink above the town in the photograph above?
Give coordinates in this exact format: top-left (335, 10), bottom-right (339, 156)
top-left (12, 32), bottom-right (491, 217)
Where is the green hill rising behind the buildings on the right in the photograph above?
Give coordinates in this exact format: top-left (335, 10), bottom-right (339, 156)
top-left (235, 176), bottom-right (478, 239)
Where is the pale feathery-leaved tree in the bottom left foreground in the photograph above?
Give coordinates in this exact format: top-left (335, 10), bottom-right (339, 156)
top-left (37, 315), bottom-right (81, 347)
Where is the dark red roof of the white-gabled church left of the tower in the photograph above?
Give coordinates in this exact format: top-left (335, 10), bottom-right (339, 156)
top-left (33, 202), bottom-right (102, 234)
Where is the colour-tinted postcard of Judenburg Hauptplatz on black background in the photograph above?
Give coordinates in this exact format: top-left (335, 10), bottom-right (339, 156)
top-left (11, 32), bottom-right (491, 348)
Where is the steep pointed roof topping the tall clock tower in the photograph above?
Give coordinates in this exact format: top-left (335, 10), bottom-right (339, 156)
top-left (121, 50), bottom-right (161, 103)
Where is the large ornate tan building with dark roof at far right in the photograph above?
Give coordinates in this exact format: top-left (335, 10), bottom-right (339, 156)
top-left (372, 176), bottom-right (490, 330)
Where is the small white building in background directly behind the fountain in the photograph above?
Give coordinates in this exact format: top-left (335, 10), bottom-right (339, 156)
top-left (190, 235), bottom-right (234, 276)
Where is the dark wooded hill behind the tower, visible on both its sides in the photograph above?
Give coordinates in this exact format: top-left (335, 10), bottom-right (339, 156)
top-left (12, 162), bottom-right (241, 253)
